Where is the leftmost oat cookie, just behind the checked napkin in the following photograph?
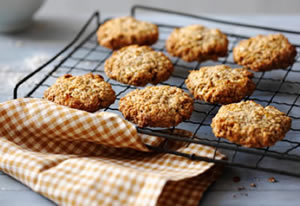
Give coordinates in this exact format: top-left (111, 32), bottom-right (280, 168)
top-left (44, 73), bottom-right (116, 112)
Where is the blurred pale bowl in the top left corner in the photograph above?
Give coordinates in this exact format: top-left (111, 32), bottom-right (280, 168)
top-left (0, 0), bottom-right (44, 32)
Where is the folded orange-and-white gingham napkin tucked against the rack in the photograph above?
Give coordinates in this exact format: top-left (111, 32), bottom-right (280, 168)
top-left (0, 98), bottom-right (223, 206)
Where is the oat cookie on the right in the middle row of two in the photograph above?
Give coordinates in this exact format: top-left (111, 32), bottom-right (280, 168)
top-left (185, 65), bottom-right (255, 104)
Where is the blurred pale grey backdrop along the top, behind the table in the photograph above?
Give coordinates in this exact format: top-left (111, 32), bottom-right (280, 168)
top-left (44, 0), bottom-right (300, 15)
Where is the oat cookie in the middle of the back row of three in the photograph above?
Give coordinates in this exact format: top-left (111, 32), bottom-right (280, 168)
top-left (166, 25), bottom-right (228, 62)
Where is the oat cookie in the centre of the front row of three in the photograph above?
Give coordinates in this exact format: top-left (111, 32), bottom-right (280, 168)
top-left (119, 86), bottom-right (193, 127)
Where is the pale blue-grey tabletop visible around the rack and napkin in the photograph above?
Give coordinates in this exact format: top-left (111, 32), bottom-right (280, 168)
top-left (0, 2), bottom-right (300, 206)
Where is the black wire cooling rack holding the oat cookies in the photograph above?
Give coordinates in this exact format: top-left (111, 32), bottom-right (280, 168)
top-left (14, 6), bottom-right (300, 177)
